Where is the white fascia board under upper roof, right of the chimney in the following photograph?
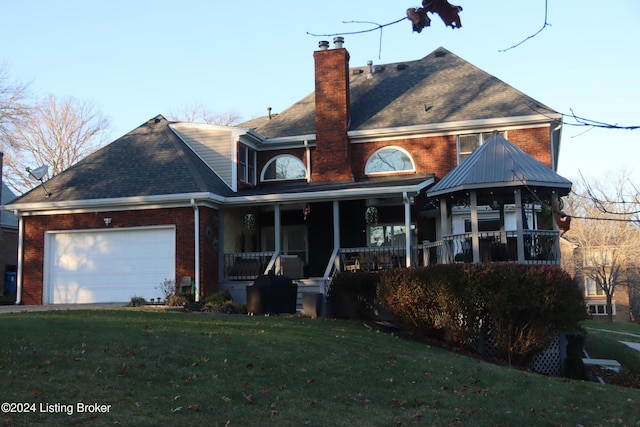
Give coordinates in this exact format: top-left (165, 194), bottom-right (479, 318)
top-left (348, 113), bottom-right (562, 142)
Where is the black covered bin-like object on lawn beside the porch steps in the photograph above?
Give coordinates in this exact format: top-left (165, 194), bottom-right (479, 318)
top-left (247, 274), bottom-right (298, 314)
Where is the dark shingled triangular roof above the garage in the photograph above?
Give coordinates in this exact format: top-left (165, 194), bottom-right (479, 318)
top-left (13, 115), bottom-right (235, 204)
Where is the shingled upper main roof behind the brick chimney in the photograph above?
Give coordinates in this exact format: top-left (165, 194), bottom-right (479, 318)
top-left (241, 47), bottom-right (557, 138)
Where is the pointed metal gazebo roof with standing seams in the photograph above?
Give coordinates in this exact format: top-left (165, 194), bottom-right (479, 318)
top-left (427, 132), bottom-right (571, 197)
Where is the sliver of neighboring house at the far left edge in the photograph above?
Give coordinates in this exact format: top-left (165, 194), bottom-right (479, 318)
top-left (0, 152), bottom-right (18, 294)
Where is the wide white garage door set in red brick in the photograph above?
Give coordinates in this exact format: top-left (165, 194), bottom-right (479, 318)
top-left (43, 227), bottom-right (176, 304)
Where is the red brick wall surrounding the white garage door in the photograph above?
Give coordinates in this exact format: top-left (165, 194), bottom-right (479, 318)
top-left (22, 207), bottom-right (218, 304)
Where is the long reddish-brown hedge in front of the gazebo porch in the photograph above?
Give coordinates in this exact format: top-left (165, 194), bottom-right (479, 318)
top-left (376, 263), bottom-right (586, 366)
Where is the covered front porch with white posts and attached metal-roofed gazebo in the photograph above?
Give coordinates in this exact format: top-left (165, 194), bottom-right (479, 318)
top-left (220, 133), bottom-right (571, 300)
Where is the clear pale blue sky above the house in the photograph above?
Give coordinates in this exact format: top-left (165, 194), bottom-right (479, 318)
top-left (0, 0), bottom-right (640, 180)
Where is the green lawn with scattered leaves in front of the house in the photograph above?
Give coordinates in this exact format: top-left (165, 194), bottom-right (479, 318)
top-left (0, 309), bottom-right (640, 426)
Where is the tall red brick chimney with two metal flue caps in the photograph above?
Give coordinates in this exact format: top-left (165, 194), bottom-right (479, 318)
top-left (311, 37), bottom-right (353, 182)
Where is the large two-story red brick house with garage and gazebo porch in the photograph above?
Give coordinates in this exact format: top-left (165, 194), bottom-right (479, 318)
top-left (0, 38), bottom-right (571, 304)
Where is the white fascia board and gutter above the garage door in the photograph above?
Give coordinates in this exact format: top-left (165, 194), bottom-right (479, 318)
top-left (3, 193), bottom-right (224, 216)
